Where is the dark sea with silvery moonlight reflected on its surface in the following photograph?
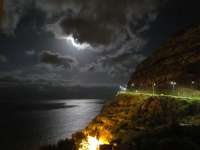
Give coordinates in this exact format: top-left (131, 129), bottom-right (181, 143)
top-left (0, 99), bottom-right (104, 150)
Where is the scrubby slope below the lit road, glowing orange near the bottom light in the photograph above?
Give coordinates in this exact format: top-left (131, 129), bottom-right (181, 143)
top-left (74, 94), bottom-right (200, 150)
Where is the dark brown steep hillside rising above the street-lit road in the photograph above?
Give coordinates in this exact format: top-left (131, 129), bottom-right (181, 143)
top-left (129, 25), bottom-right (200, 87)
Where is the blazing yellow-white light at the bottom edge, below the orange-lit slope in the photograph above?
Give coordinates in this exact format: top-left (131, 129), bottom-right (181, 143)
top-left (79, 136), bottom-right (109, 150)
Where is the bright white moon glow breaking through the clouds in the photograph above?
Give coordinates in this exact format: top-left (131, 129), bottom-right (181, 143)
top-left (64, 35), bottom-right (91, 50)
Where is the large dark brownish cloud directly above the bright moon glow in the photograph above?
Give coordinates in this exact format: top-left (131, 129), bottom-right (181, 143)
top-left (57, 0), bottom-right (166, 45)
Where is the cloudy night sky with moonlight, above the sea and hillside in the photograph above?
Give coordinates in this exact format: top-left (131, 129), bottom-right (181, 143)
top-left (0, 0), bottom-right (200, 86)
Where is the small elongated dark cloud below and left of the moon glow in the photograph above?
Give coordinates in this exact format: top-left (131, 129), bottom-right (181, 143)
top-left (40, 51), bottom-right (78, 69)
